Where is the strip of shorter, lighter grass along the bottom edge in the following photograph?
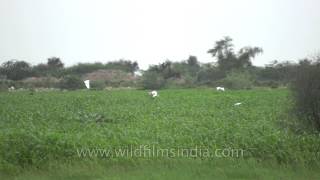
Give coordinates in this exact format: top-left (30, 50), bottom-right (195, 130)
top-left (0, 159), bottom-right (320, 180)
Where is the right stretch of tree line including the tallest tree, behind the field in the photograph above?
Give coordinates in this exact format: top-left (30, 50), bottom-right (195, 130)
top-left (141, 37), bottom-right (312, 89)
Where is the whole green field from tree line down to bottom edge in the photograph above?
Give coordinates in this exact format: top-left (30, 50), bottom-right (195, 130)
top-left (0, 89), bottom-right (320, 179)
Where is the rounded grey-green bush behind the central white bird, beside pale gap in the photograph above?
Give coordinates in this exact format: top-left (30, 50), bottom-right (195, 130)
top-left (141, 71), bottom-right (166, 89)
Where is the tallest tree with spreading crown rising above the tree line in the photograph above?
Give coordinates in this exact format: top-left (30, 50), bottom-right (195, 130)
top-left (208, 36), bottom-right (263, 72)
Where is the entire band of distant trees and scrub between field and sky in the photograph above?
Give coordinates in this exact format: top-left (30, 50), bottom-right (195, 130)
top-left (0, 37), bottom-right (310, 90)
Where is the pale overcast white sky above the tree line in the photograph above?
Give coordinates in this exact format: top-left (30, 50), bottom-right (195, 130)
top-left (0, 0), bottom-right (320, 69)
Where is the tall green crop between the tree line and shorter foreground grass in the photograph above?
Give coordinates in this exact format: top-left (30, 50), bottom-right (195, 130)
top-left (0, 89), bottom-right (320, 176)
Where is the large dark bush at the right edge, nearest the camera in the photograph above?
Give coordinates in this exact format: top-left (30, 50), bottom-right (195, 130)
top-left (292, 63), bottom-right (320, 132)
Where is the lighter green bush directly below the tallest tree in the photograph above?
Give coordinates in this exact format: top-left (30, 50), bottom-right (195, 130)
top-left (219, 71), bottom-right (254, 89)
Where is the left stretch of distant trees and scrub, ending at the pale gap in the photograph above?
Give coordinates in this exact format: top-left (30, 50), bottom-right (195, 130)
top-left (0, 57), bottom-right (139, 90)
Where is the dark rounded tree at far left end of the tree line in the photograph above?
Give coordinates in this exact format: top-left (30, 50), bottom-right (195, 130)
top-left (1, 60), bottom-right (32, 80)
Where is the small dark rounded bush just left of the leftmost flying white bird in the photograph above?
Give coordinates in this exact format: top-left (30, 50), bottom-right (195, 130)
top-left (59, 75), bottom-right (85, 90)
